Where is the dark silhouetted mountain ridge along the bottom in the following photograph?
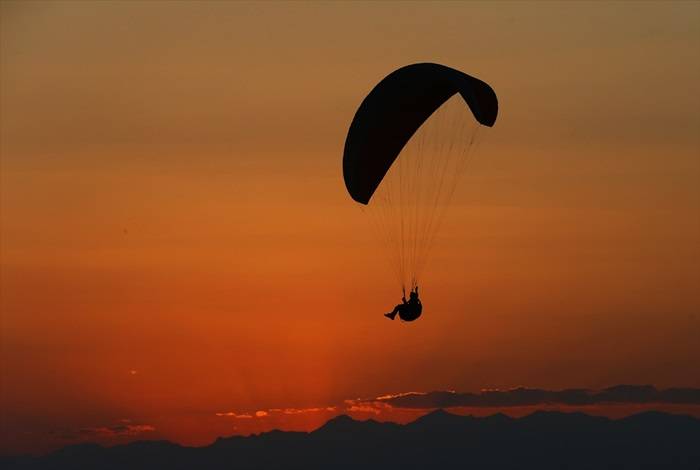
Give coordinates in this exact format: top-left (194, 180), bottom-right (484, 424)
top-left (0, 410), bottom-right (700, 470)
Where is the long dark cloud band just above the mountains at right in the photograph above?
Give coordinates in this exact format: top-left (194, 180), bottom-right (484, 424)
top-left (364, 385), bottom-right (700, 409)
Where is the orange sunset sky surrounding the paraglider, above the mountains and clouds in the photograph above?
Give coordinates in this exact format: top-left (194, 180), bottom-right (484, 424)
top-left (0, 1), bottom-right (700, 452)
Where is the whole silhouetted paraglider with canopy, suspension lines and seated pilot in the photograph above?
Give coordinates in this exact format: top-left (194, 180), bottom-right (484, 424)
top-left (343, 63), bottom-right (498, 321)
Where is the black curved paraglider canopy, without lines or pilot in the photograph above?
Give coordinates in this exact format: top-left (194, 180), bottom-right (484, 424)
top-left (343, 63), bottom-right (498, 204)
